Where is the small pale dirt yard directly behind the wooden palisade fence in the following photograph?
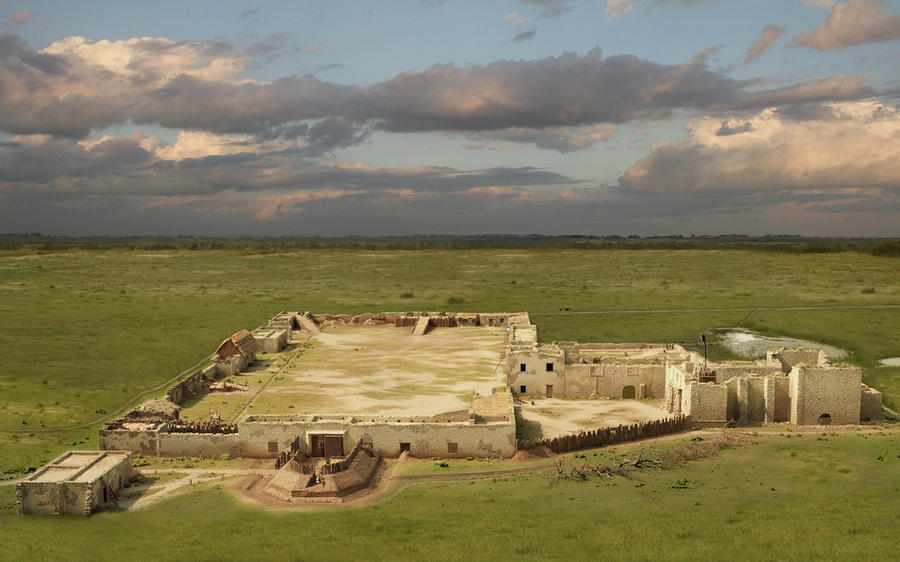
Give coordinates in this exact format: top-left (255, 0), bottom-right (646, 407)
top-left (519, 398), bottom-right (668, 439)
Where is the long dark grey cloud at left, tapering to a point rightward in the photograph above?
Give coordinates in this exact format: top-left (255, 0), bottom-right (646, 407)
top-left (0, 135), bottom-right (573, 199)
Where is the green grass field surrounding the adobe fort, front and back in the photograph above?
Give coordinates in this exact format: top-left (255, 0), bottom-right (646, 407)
top-left (0, 250), bottom-right (900, 559)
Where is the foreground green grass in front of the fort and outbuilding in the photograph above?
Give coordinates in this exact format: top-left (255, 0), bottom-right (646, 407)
top-left (0, 430), bottom-right (900, 560)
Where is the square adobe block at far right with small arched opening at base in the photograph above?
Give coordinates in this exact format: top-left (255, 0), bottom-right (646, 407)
top-left (790, 365), bottom-right (862, 425)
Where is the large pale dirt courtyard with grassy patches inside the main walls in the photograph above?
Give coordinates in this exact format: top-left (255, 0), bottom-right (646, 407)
top-left (235, 326), bottom-right (506, 416)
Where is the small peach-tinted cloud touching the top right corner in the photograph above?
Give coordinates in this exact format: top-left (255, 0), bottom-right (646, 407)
top-left (789, 0), bottom-right (900, 51)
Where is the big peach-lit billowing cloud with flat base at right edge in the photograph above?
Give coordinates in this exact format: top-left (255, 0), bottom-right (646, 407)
top-left (619, 101), bottom-right (900, 194)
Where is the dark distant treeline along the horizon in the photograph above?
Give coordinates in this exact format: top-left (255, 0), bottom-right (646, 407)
top-left (0, 233), bottom-right (900, 256)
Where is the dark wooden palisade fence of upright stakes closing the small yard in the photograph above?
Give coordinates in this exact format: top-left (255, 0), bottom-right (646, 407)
top-left (517, 416), bottom-right (691, 453)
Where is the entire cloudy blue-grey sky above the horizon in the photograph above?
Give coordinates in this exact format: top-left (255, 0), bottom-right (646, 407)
top-left (0, 0), bottom-right (900, 237)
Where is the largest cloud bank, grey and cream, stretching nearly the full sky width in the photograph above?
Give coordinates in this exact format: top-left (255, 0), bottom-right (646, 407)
top-left (0, 34), bottom-right (876, 146)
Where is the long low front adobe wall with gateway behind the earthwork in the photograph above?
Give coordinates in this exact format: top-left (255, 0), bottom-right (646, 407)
top-left (238, 416), bottom-right (516, 458)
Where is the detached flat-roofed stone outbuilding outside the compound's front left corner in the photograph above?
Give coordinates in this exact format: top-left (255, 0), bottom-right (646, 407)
top-left (16, 451), bottom-right (134, 515)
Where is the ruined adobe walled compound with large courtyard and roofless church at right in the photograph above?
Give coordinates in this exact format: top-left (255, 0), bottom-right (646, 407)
top-left (100, 312), bottom-right (881, 458)
